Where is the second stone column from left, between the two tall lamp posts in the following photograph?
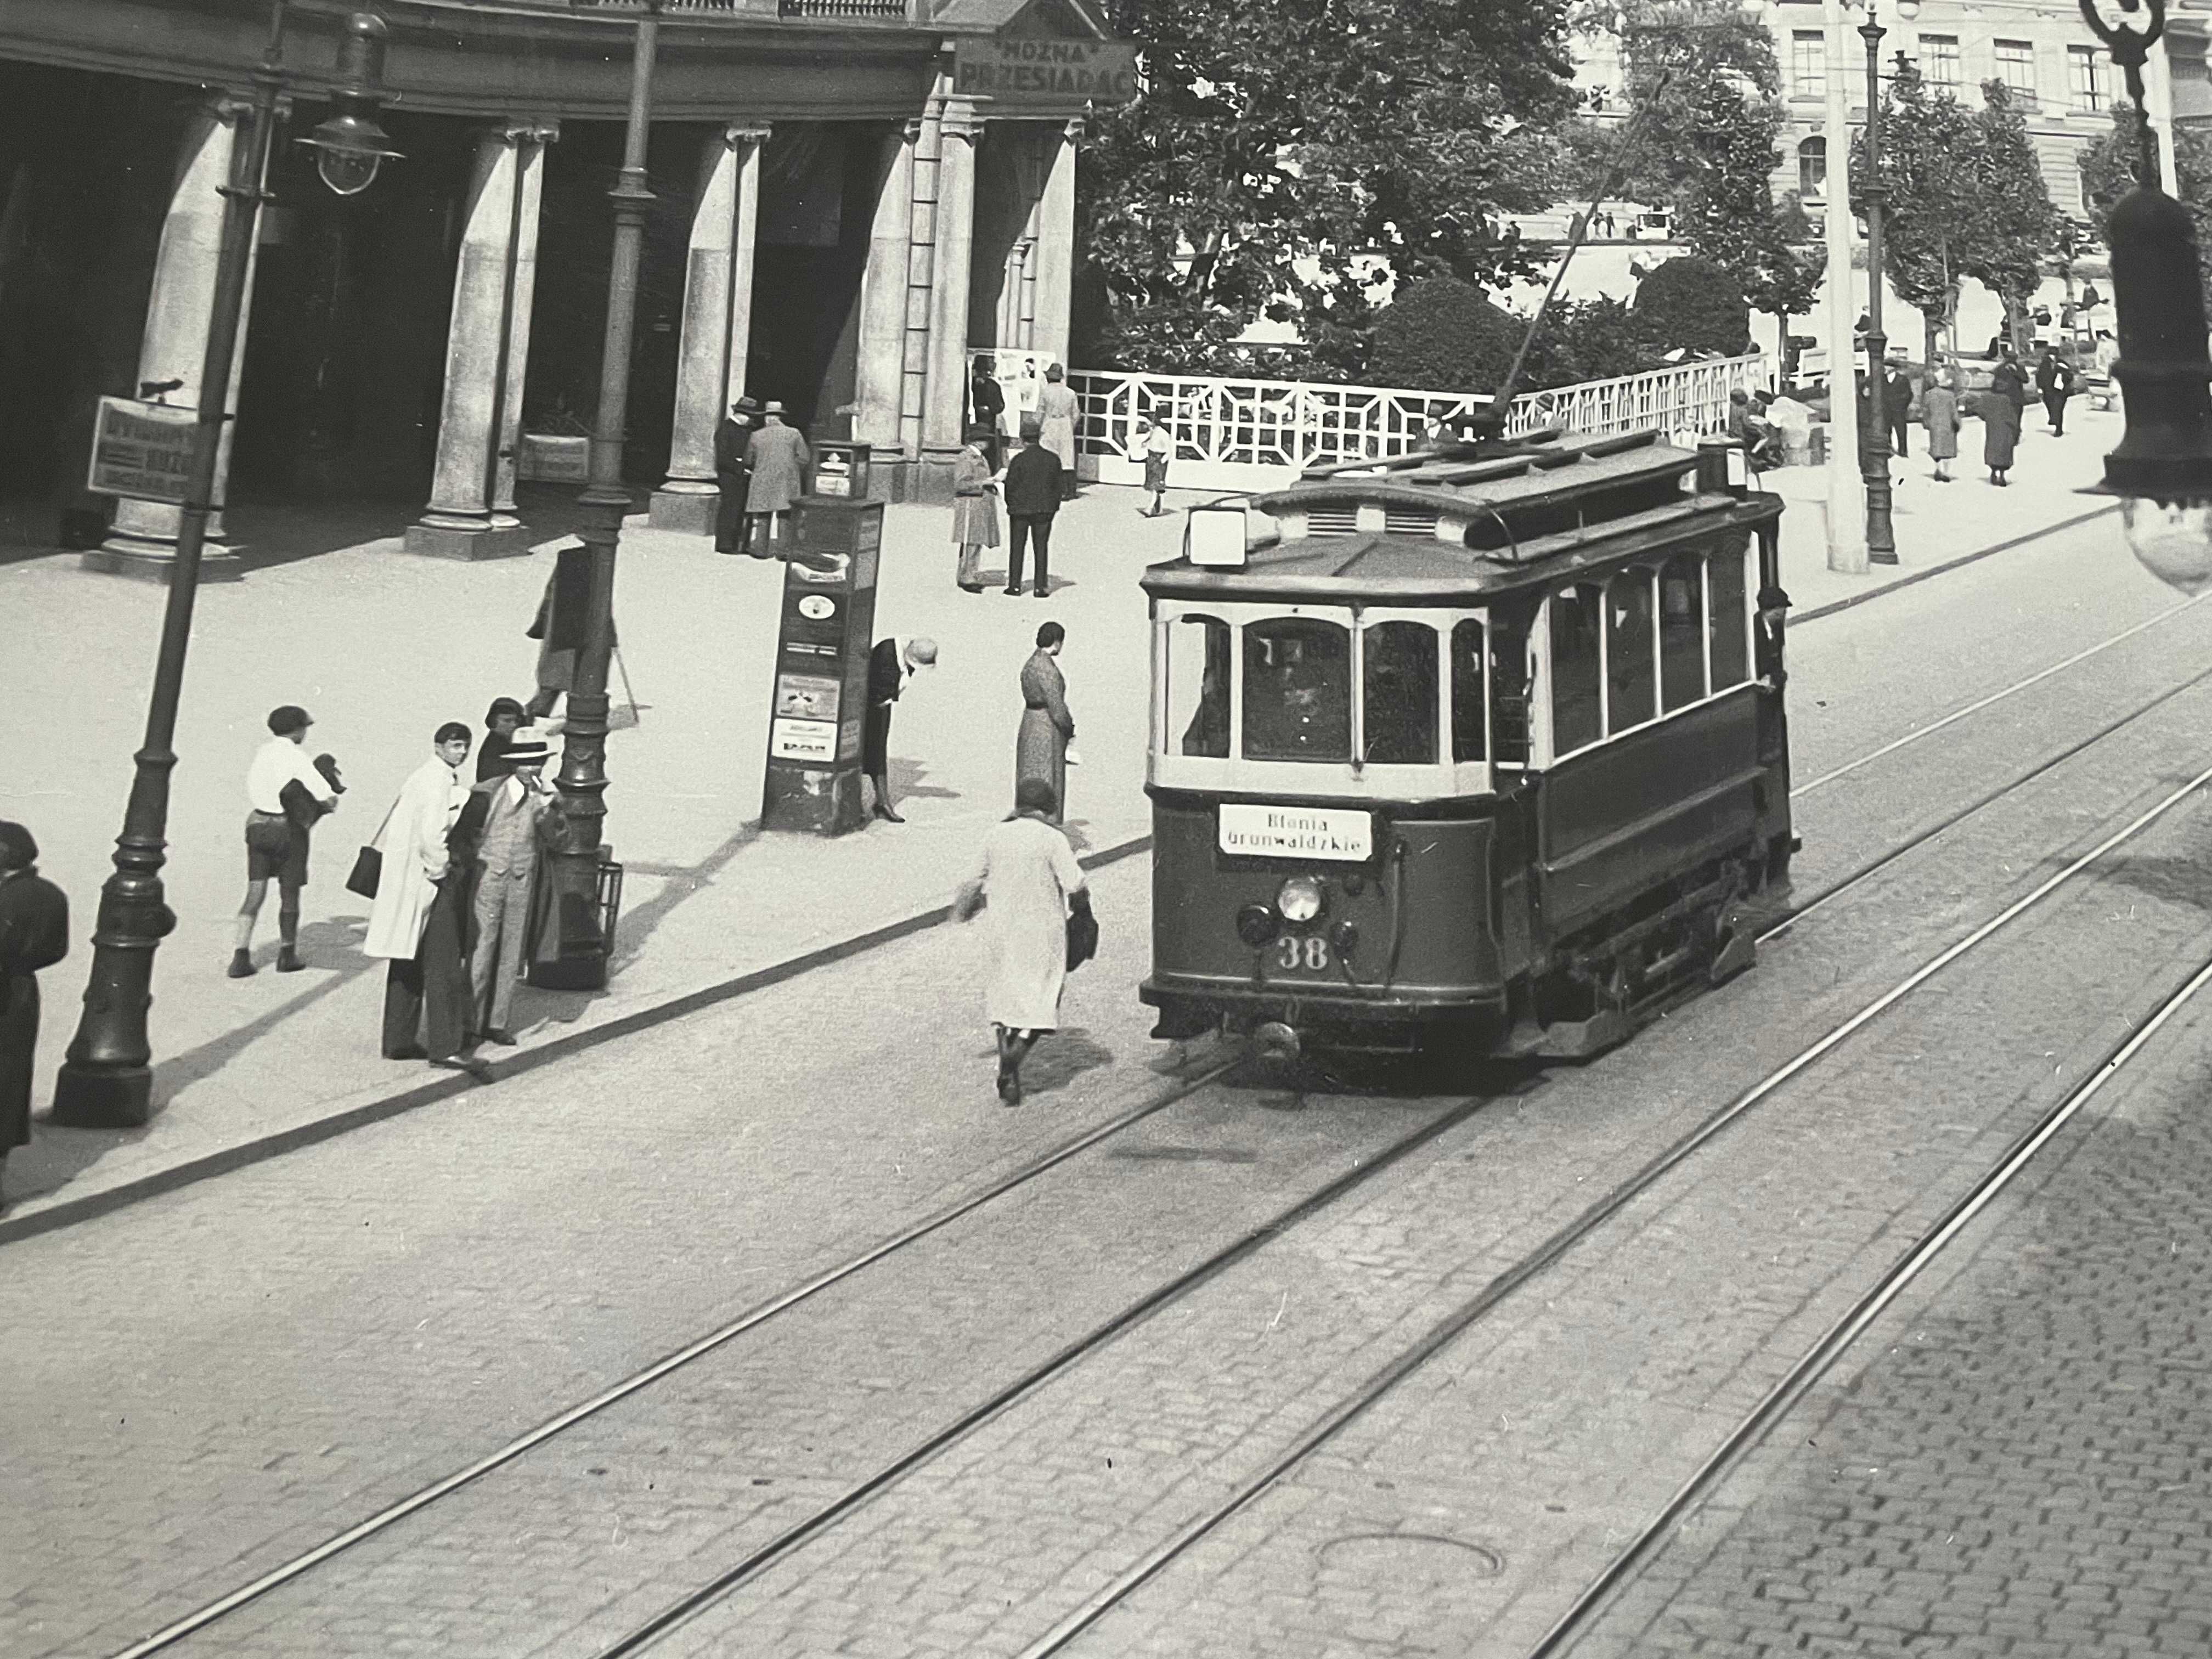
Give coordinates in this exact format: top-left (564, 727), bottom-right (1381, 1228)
top-left (407, 124), bottom-right (553, 560)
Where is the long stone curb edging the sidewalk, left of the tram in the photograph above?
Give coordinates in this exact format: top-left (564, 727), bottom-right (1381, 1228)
top-left (0, 836), bottom-right (1153, 1245)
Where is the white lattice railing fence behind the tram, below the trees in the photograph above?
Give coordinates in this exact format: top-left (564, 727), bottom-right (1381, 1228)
top-left (1068, 354), bottom-right (1774, 489)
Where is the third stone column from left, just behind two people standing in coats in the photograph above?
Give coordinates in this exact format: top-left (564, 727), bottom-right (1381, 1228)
top-left (652, 126), bottom-right (768, 535)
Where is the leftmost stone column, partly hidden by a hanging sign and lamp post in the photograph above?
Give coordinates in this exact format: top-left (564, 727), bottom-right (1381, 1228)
top-left (84, 97), bottom-right (259, 582)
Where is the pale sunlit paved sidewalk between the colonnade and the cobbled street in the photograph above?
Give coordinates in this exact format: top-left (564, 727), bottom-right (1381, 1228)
top-left (0, 416), bottom-right (2119, 1239)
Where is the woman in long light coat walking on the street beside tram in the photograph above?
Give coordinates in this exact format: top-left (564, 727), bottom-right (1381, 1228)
top-left (953, 778), bottom-right (1091, 1106)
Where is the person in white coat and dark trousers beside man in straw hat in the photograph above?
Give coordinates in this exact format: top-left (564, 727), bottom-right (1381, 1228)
top-left (360, 721), bottom-right (473, 1068)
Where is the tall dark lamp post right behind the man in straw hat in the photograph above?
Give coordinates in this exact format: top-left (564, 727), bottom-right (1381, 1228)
top-left (531, 0), bottom-right (659, 991)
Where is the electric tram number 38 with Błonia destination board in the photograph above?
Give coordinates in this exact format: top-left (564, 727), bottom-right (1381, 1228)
top-left (1139, 431), bottom-right (1796, 1059)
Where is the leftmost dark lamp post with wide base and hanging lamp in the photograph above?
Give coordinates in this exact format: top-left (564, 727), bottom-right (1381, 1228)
top-left (53, 0), bottom-right (398, 1128)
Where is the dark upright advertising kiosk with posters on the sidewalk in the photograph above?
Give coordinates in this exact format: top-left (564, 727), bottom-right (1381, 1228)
top-left (761, 495), bottom-right (883, 836)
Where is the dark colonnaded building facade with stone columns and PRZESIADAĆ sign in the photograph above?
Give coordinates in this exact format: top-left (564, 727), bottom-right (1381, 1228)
top-left (0, 0), bottom-right (1104, 575)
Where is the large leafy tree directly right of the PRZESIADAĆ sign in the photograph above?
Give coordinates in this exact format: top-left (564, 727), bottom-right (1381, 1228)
top-left (1080, 0), bottom-right (1575, 371)
